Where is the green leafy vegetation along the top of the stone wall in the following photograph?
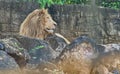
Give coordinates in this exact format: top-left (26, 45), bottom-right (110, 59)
top-left (23, 0), bottom-right (120, 9)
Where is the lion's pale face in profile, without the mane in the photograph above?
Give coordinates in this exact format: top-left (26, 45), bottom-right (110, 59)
top-left (39, 9), bottom-right (57, 34)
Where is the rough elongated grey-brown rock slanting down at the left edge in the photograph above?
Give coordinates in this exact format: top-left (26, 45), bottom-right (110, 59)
top-left (0, 38), bottom-right (29, 67)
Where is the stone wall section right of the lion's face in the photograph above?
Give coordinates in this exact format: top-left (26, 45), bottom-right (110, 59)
top-left (50, 5), bottom-right (120, 43)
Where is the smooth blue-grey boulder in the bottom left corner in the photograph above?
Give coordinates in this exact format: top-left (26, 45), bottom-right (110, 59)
top-left (0, 50), bottom-right (21, 74)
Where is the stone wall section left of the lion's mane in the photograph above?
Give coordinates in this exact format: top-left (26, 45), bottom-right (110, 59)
top-left (0, 0), bottom-right (39, 38)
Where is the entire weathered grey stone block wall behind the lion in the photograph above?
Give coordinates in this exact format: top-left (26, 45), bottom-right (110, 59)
top-left (0, 0), bottom-right (120, 43)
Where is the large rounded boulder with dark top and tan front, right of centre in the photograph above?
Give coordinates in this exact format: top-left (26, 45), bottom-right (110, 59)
top-left (56, 36), bottom-right (97, 74)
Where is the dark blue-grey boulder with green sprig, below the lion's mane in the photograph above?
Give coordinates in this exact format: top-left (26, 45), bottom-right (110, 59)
top-left (16, 36), bottom-right (58, 69)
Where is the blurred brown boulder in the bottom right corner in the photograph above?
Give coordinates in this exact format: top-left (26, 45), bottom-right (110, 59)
top-left (91, 51), bottom-right (120, 74)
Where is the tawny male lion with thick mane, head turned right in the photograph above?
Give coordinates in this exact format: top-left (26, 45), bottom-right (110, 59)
top-left (19, 9), bottom-right (56, 40)
